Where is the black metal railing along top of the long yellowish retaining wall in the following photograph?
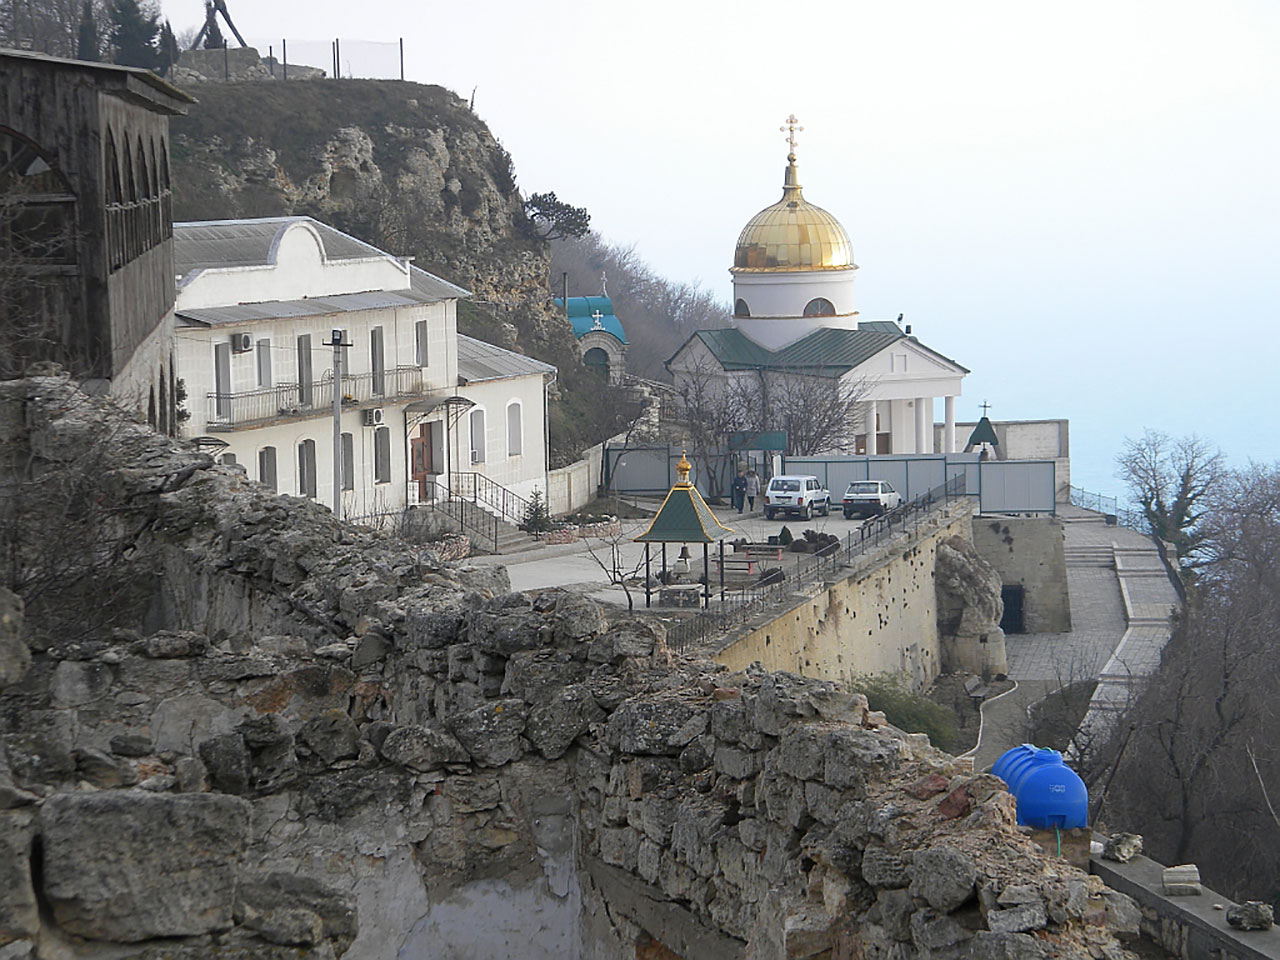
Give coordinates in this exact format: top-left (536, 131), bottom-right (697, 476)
top-left (667, 475), bottom-right (966, 653)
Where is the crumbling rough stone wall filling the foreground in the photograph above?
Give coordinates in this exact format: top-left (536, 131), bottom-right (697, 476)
top-left (0, 380), bottom-right (1125, 960)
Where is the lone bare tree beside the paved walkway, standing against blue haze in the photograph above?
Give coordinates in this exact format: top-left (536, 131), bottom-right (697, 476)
top-left (1116, 430), bottom-right (1225, 576)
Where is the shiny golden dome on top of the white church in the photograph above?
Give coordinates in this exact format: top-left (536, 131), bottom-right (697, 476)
top-left (732, 154), bottom-right (855, 273)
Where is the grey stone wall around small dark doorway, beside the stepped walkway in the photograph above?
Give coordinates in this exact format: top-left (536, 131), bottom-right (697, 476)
top-left (973, 517), bottom-right (1071, 634)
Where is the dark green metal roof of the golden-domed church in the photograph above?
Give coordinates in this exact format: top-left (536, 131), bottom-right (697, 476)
top-left (667, 321), bottom-right (969, 378)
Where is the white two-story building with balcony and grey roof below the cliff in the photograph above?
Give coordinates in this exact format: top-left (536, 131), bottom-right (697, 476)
top-left (174, 216), bottom-right (556, 518)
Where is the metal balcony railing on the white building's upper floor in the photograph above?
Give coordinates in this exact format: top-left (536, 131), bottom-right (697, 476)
top-left (206, 366), bottom-right (422, 433)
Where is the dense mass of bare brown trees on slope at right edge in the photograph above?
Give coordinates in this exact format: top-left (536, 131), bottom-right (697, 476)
top-left (1108, 465), bottom-right (1280, 899)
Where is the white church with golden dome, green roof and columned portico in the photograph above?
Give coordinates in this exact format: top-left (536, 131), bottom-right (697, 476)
top-left (667, 115), bottom-right (969, 454)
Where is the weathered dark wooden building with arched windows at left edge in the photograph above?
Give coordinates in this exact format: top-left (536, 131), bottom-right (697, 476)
top-left (0, 50), bottom-right (195, 431)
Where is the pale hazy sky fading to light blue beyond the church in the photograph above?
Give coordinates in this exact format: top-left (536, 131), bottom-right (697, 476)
top-left (163, 0), bottom-right (1280, 493)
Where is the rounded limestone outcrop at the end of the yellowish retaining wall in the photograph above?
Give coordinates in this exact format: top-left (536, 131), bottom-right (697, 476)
top-left (934, 536), bottom-right (1009, 676)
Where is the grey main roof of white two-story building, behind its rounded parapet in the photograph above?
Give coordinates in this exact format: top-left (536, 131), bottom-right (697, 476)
top-left (173, 216), bottom-right (471, 302)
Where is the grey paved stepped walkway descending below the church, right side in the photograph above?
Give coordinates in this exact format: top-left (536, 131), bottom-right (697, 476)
top-left (974, 506), bottom-right (1178, 769)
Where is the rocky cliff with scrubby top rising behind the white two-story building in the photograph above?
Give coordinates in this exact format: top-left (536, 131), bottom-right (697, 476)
top-left (172, 81), bottom-right (567, 352)
